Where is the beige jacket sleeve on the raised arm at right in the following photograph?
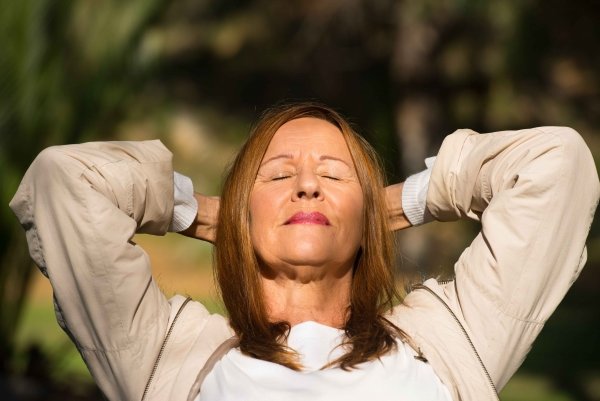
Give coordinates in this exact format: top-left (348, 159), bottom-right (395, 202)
top-left (427, 127), bottom-right (600, 389)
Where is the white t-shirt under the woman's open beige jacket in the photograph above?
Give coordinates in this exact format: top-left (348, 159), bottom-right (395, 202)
top-left (196, 321), bottom-right (451, 401)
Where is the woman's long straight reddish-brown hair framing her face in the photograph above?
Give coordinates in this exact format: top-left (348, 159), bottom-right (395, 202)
top-left (215, 103), bottom-right (404, 370)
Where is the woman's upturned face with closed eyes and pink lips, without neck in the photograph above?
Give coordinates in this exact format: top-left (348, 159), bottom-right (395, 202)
top-left (250, 118), bottom-right (363, 274)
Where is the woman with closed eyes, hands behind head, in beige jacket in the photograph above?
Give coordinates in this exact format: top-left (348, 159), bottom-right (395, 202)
top-left (11, 104), bottom-right (600, 400)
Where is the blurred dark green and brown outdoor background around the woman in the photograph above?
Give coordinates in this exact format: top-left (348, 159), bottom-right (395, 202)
top-left (0, 0), bottom-right (600, 401)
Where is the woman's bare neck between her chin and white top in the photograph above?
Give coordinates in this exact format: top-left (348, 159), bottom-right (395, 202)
top-left (262, 267), bottom-right (352, 328)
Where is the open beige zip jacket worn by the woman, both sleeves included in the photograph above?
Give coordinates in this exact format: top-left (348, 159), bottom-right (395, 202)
top-left (10, 127), bottom-right (600, 401)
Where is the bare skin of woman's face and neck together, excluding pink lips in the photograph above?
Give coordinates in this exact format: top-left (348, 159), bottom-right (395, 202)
top-left (250, 118), bottom-right (363, 327)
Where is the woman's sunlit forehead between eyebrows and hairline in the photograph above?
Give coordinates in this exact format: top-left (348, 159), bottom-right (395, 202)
top-left (265, 117), bottom-right (352, 162)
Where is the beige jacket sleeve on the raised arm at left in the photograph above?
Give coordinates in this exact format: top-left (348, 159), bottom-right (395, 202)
top-left (10, 141), bottom-right (173, 400)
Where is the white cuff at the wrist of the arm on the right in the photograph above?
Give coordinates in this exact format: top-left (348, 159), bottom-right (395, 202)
top-left (402, 156), bottom-right (435, 226)
